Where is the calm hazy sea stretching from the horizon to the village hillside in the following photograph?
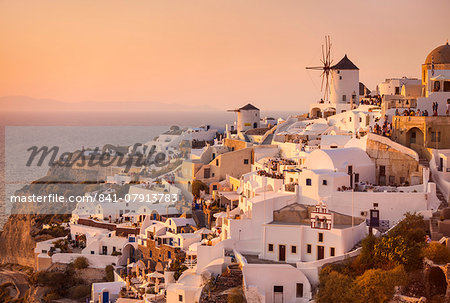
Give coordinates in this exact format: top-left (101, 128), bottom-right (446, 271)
top-left (0, 110), bottom-right (301, 230)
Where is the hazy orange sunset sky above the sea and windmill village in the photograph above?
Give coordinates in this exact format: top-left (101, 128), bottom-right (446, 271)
top-left (0, 0), bottom-right (450, 110)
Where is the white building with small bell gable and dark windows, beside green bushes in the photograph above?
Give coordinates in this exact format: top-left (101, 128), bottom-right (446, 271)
top-left (259, 202), bottom-right (367, 263)
